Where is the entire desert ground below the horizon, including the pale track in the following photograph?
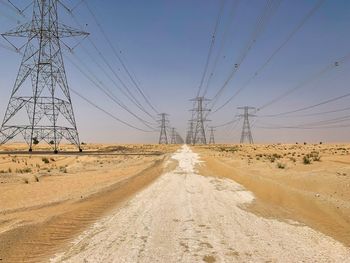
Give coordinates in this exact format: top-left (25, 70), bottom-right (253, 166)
top-left (0, 144), bottom-right (350, 262)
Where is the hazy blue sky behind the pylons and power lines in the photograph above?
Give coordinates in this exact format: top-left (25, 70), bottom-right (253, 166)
top-left (0, 0), bottom-right (350, 143)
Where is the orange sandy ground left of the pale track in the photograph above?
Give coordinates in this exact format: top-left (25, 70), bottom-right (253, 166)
top-left (0, 144), bottom-right (178, 262)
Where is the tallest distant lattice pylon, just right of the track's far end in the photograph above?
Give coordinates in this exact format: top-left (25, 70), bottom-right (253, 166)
top-left (191, 97), bottom-right (209, 144)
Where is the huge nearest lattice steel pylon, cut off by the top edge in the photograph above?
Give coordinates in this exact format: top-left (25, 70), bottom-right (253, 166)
top-left (0, 0), bottom-right (88, 153)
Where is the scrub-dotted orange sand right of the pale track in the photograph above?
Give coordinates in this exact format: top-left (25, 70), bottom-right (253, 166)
top-left (195, 144), bottom-right (350, 246)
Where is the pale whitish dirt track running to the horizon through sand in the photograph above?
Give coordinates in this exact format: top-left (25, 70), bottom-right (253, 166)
top-left (51, 146), bottom-right (350, 262)
